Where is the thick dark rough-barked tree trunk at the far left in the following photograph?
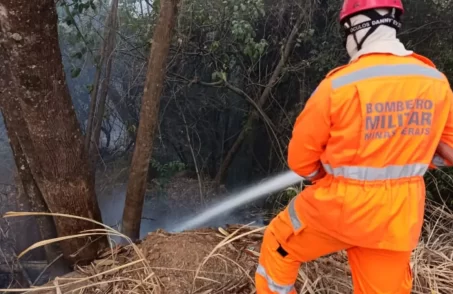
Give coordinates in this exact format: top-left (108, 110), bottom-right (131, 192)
top-left (0, 0), bottom-right (108, 263)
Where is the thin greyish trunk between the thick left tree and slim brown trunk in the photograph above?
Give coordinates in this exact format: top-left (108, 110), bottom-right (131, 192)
top-left (87, 0), bottom-right (118, 170)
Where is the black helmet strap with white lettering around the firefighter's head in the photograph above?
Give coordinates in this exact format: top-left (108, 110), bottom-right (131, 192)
top-left (343, 8), bottom-right (401, 50)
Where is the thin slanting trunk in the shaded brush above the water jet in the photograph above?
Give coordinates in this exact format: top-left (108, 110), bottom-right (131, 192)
top-left (215, 15), bottom-right (303, 187)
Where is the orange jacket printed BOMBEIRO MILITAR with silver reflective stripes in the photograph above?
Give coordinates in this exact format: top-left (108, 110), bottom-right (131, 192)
top-left (284, 54), bottom-right (453, 251)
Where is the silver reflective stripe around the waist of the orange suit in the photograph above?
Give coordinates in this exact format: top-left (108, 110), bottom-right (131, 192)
top-left (323, 163), bottom-right (429, 181)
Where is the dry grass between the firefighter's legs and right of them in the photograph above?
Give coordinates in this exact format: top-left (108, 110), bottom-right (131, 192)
top-left (292, 202), bottom-right (453, 294)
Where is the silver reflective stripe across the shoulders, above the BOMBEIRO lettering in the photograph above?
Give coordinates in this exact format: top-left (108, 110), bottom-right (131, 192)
top-left (332, 64), bottom-right (443, 89)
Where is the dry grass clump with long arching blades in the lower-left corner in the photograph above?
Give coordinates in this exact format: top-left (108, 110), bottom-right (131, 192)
top-left (0, 212), bottom-right (160, 294)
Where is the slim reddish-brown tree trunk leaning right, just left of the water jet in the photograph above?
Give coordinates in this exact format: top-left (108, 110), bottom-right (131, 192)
top-left (122, 0), bottom-right (180, 239)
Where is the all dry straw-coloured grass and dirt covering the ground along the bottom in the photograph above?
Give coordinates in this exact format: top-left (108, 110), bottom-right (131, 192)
top-left (0, 199), bottom-right (453, 294)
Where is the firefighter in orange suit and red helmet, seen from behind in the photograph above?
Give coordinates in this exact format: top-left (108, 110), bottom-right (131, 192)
top-left (255, 0), bottom-right (453, 294)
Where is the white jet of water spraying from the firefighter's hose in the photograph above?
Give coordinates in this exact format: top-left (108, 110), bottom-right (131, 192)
top-left (174, 171), bottom-right (304, 232)
